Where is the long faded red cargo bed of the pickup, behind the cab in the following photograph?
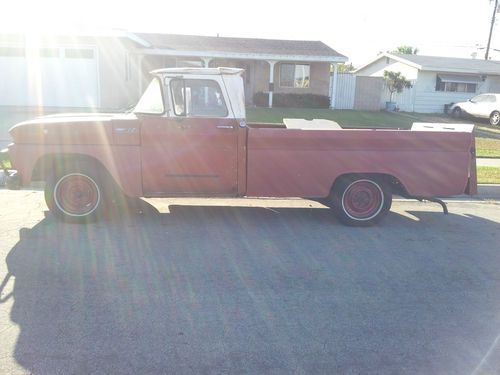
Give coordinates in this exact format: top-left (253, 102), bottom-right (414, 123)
top-left (247, 124), bottom-right (475, 198)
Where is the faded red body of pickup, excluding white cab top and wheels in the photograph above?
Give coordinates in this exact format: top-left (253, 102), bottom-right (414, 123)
top-left (6, 114), bottom-right (476, 198)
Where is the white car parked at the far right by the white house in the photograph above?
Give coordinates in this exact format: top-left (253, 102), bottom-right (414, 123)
top-left (449, 94), bottom-right (500, 125)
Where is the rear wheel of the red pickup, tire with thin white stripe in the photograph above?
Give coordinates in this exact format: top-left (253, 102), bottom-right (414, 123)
top-left (330, 176), bottom-right (392, 226)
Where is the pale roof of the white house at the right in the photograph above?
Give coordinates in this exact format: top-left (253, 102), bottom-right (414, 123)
top-left (393, 54), bottom-right (500, 75)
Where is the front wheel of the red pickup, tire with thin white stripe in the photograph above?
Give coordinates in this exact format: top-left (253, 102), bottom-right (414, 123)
top-left (45, 162), bottom-right (108, 223)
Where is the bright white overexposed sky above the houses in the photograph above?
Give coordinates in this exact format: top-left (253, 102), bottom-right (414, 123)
top-left (0, 0), bottom-right (500, 67)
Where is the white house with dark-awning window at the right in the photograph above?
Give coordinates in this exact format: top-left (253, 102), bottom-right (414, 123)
top-left (354, 53), bottom-right (500, 113)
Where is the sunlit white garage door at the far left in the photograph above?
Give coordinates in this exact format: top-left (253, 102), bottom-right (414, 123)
top-left (0, 47), bottom-right (99, 108)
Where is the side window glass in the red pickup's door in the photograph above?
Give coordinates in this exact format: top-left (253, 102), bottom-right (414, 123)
top-left (170, 79), bottom-right (228, 117)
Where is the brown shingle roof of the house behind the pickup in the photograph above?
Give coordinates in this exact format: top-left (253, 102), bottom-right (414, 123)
top-left (134, 33), bottom-right (345, 57)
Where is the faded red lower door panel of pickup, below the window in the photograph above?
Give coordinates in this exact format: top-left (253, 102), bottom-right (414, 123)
top-left (140, 115), bottom-right (238, 196)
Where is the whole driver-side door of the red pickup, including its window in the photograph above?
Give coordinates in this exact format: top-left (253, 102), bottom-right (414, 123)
top-left (141, 76), bottom-right (238, 196)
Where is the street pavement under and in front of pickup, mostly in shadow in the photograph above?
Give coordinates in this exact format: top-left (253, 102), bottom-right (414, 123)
top-left (0, 190), bottom-right (500, 374)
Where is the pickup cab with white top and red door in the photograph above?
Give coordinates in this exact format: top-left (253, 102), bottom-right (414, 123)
top-left (134, 68), bottom-right (246, 196)
